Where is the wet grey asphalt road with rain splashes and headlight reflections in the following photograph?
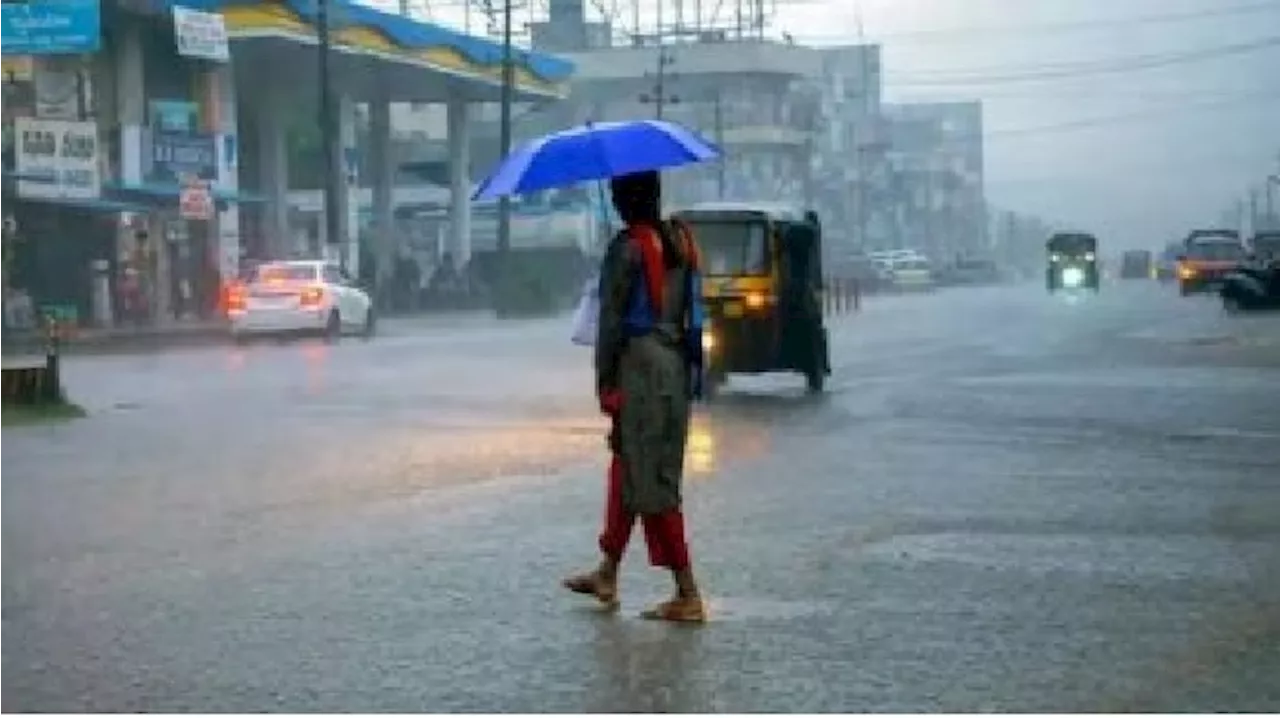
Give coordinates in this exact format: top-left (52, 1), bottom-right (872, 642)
top-left (0, 284), bottom-right (1280, 712)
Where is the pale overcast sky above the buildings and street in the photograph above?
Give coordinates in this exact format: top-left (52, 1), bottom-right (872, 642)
top-left (380, 0), bottom-right (1280, 247)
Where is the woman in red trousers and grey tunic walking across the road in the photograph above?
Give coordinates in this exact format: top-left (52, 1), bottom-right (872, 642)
top-left (564, 172), bottom-right (707, 622)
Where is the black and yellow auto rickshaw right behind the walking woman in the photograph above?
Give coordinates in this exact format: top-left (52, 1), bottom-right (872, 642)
top-left (675, 202), bottom-right (831, 397)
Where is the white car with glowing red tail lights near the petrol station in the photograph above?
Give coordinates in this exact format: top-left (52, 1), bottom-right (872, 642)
top-left (227, 260), bottom-right (376, 340)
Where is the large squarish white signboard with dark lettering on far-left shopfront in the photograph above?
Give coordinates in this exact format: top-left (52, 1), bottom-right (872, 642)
top-left (13, 118), bottom-right (101, 200)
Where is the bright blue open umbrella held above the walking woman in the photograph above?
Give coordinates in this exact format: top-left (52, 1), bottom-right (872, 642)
top-left (475, 120), bottom-right (721, 200)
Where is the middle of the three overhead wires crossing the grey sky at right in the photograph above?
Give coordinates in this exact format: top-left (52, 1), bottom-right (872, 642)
top-left (893, 37), bottom-right (1280, 86)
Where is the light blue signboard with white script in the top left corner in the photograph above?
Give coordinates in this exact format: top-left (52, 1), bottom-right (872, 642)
top-left (0, 0), bottom-right (102, 55)
